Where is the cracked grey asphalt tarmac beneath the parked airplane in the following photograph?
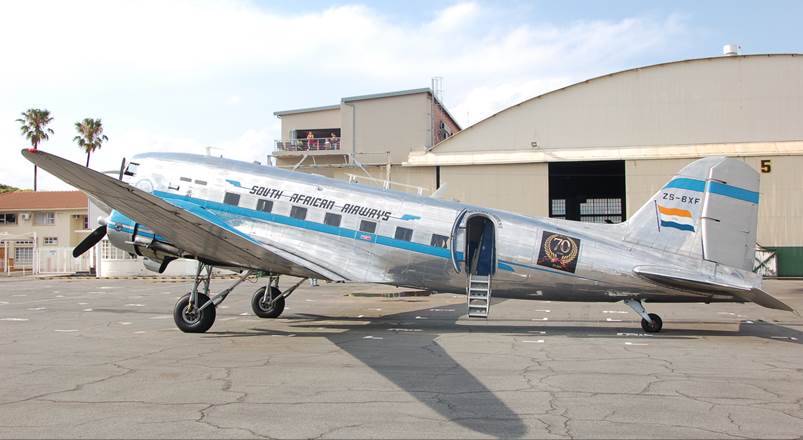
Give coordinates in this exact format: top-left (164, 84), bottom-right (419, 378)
top-left (0, 279), bottom-right (803, 439)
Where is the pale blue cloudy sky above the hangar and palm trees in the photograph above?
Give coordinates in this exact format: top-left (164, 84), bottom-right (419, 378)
top-left (0, 0), bottom-right (803, 190)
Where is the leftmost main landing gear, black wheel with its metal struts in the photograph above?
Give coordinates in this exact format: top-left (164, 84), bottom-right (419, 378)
top-left (173, 262), bottom-right (252, 333)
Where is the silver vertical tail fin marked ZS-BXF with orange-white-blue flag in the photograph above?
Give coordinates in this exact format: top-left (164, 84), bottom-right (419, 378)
top-left (627, 157), bottom-right (759, 270)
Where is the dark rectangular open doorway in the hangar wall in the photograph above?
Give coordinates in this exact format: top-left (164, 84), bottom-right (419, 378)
top-left (549, 160), bottom-right (626, 223)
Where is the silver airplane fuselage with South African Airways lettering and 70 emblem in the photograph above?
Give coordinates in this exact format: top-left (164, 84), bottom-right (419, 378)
top-left (111, 153), bottom-right (760, 302)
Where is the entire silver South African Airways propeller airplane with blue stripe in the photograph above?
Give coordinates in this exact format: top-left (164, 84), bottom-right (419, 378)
top-left (22, 149), bottom-right (794, 332)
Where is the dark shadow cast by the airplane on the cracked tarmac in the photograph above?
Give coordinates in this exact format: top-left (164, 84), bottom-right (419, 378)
top-left (205, 300), bottom-right (803, 437)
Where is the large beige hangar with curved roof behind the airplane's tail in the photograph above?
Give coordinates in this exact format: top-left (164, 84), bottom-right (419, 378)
top-left (404, 54), bottom-right (803, 276)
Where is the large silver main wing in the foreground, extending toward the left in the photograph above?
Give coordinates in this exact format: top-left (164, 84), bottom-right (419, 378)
top-left (22, 149), bottom-right (346, 281)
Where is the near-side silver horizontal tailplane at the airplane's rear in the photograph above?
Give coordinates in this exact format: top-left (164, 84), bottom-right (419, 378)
top-left (633, 266), bottom-right (795, 312)
